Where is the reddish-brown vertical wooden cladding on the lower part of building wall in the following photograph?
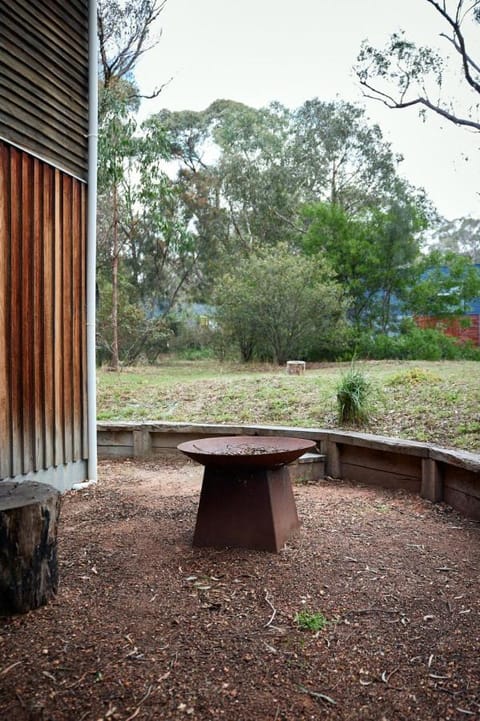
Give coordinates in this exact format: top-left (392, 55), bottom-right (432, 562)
top-left (0, 142), bottom-right (87, 478)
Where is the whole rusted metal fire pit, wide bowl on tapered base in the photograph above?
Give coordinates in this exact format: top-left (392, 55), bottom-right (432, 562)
top-left (178, 436), bottom-right (315, 552)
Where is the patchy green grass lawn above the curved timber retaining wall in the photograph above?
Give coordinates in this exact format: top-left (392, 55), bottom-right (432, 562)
top-left (97, 358), bottom-right (480, 452)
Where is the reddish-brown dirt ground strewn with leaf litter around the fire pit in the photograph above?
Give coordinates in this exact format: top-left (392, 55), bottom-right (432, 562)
top-left (0, 461), bottom-right (480, 721)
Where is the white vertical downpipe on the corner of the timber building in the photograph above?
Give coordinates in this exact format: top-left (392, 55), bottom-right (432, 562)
top-left (87, 0), bottom-right (98, 482)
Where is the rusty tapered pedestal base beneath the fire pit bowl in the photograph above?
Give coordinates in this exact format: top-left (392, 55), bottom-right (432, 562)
top-left (193, 466), bottom-right (300, 552)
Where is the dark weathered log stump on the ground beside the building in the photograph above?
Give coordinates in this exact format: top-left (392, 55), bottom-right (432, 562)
top-left (0, 481), bottom-right (60, 616)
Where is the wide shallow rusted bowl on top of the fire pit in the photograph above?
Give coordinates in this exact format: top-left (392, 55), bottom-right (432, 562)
top-left (177, 436), bottom-right (316, 468)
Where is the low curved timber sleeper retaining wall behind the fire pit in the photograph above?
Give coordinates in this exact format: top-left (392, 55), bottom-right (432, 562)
top-left (97, 422), bottom-right (480, 520)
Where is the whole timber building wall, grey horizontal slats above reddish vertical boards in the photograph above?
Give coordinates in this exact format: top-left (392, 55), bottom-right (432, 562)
top-left (0, 0), bottom-right (88, 487)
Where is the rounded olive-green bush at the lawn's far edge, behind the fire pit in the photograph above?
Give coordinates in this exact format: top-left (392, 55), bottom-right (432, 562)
top-left (216, 244), bottom-right (346, 364)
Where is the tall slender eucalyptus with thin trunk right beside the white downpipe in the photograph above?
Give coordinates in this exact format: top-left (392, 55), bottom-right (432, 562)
top-left (97, 0), bottom-right (171, 362)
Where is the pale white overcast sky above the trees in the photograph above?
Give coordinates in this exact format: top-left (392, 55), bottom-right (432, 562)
top-left (136, 0), bottom-right (480, 219)
